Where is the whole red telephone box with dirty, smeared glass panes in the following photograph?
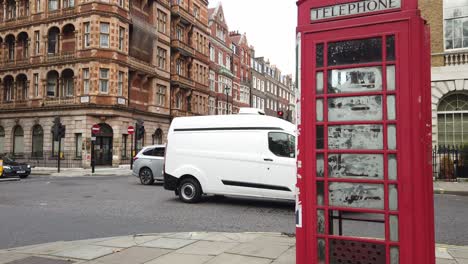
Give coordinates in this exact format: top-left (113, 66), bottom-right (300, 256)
top-left (296, 0), bottom-right (435, 264)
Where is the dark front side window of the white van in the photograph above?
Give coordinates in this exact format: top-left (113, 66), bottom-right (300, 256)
top-left (268, 132), bottom-right (296, 158)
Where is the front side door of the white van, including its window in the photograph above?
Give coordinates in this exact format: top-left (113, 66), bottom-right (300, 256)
top-left (262, 132), bottom-right (296, 199)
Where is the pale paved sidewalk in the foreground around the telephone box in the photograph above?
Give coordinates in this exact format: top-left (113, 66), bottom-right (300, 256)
top-left (0, 232), bottom-right (468, 264)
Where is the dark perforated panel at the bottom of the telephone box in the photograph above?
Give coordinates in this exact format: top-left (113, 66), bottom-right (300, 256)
top-left (330, 239), bottom-right (386, 264)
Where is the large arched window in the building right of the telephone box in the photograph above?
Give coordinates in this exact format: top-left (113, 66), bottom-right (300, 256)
top-left (437, 92), bottom-right (468, 145)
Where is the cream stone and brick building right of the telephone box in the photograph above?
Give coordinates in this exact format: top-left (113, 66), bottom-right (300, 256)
top-left (419, 0), bottom-right (468, 145)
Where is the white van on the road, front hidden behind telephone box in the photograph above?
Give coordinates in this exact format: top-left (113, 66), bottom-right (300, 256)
top-left (164, 112), bottom-right (296, 203)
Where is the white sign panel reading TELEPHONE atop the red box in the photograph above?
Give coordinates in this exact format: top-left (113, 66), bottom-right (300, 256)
top-left (310, 0), bottom-right (401, 21)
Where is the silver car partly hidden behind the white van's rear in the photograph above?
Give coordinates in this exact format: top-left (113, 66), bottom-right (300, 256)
top-left (133, 145), bottom-right (166, 185)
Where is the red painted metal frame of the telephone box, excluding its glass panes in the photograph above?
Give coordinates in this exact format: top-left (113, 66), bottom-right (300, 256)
top-left (296, 0), bottom-right (435, 264)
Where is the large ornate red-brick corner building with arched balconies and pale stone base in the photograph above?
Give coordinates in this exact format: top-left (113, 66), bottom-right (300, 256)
top-left (0, 0), bottom-right (208, 167)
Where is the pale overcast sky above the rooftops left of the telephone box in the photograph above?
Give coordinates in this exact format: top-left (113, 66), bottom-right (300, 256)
top-left (209, 0), bottom-right (297, 74)
